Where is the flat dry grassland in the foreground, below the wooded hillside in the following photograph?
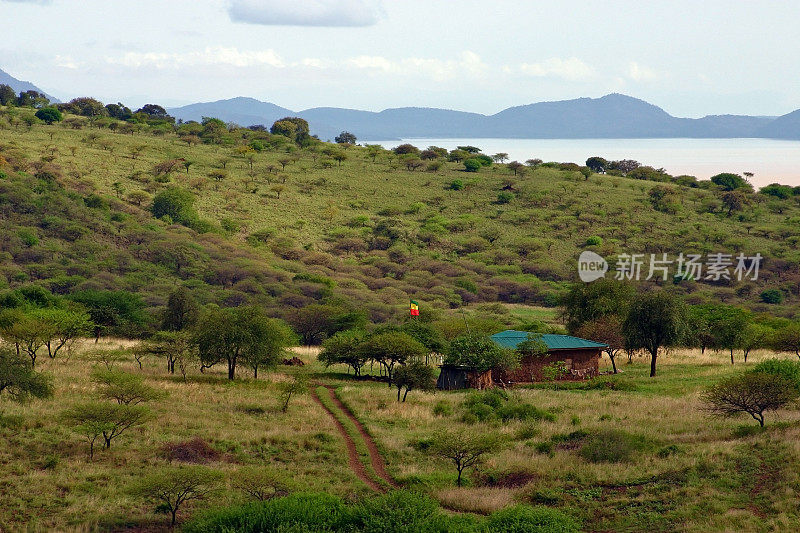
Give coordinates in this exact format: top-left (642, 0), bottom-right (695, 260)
top-left (0, 340), bottom-right (800, 531)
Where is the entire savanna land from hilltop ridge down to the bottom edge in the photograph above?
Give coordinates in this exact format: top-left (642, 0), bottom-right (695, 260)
top-left (0, 102), bottom-right (800, 532)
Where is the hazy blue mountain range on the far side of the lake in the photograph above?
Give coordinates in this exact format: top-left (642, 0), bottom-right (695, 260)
top-left (169, 94), bottom-right (800, 140)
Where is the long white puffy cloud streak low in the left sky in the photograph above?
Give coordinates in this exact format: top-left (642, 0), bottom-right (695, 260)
top-left (106, 46), bottom-right (285, 69)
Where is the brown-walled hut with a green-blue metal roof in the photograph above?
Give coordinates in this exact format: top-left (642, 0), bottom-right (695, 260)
top-left (491, 330), bottom-right (607, 383)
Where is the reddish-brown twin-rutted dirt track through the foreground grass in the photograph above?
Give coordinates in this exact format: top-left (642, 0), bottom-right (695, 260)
top-left (312, 383), bottom-right (398, 492)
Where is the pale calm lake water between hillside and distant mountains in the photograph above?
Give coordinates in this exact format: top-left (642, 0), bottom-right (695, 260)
top-left (364, 139), bottom-right (800, 187)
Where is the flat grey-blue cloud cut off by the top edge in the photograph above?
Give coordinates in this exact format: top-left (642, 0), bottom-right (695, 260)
top-left (228, 0), bottom-right (383, 27)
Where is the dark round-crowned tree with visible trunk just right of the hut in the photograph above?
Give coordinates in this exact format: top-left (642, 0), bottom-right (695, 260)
top-left (622, 290), bottom-right (686, 377)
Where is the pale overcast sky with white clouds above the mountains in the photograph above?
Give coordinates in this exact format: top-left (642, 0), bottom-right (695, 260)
top-left (0, 0), bottom-right (800, 117)
